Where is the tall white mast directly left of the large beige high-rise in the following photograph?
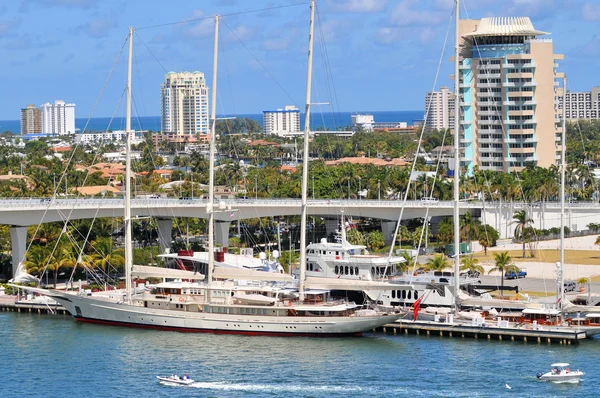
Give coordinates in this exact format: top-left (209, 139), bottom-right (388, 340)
top-left (453, 0), bottom-right (460, 312)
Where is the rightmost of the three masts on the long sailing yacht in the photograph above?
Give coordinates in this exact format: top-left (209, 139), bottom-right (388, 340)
top-left (300, 0), bottom-right (315, 300)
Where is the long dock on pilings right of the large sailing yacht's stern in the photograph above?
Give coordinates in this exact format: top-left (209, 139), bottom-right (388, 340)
top-left (377, 319), bottom-right (600, 345)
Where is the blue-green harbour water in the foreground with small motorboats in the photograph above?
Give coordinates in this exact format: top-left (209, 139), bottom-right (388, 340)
top-left (0, 312), bottom-right (600, 398)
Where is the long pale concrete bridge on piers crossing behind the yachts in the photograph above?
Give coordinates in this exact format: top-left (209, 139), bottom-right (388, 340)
top-left (0, 198), bottom-right (600, 276)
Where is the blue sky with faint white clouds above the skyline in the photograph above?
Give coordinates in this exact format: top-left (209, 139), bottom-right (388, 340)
top-left (0, 0), bottom-right (600, 120)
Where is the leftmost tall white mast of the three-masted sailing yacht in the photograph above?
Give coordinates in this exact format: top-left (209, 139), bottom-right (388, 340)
top-left (124, 27), bottom-right (133, 303)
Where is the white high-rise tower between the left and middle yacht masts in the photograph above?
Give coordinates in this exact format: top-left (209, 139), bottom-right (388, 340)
top-left (160, 71), bottom-right (209, 142)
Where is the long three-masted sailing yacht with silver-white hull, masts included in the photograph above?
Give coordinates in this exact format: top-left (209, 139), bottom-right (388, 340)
top-left (16, 4), bottom-right (400, 337)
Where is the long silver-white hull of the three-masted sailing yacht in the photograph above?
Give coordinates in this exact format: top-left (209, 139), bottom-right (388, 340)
top-left (51, 292), bottom-right (400, 337)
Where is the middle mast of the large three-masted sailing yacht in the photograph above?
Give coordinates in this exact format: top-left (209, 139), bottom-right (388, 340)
top-left (206, 15), bottom-right (221, 295)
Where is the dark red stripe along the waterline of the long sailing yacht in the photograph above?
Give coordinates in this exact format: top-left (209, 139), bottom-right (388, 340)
top-left (70, 317), bottom-right (362, 337)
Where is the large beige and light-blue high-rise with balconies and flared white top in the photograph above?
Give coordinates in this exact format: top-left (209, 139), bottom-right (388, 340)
top-left (458, 17), bottom-right (564, 172)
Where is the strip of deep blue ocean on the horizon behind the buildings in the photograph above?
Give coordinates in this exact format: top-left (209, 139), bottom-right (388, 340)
top-left (0, 111), bottom-right (423, 134)
